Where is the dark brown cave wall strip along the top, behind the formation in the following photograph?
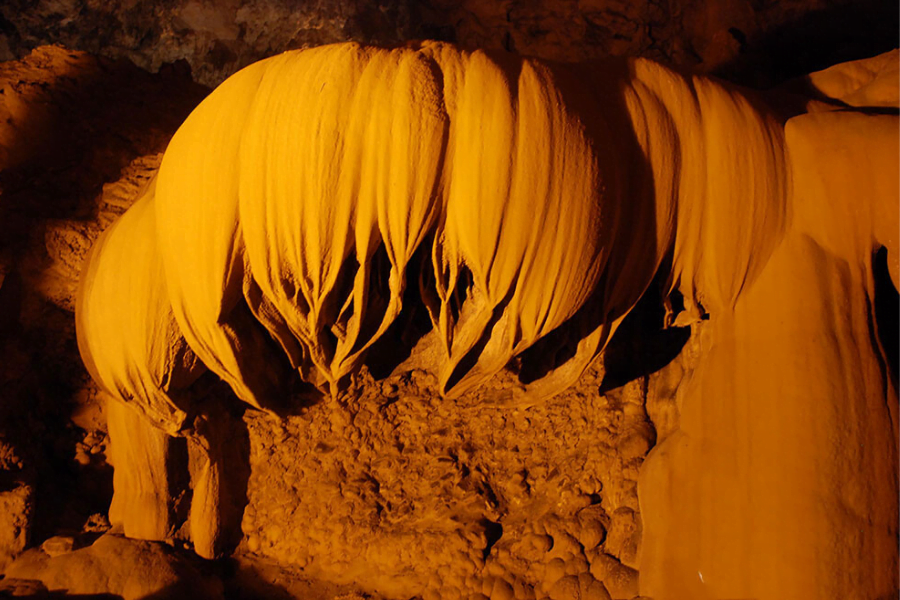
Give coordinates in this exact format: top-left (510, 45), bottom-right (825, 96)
top-left (0, 0), bottom-right (898, 86)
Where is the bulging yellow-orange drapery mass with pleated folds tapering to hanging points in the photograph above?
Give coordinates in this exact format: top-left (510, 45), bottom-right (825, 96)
top-left (78, 43), bottom-right (785, 422)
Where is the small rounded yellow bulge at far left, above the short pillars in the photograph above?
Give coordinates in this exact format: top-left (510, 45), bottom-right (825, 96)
top-left (76, 182), bottom-right (205, 434)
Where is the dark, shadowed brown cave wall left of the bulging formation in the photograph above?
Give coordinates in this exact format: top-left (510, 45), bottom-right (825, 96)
top-left (0, 48), bottom-right (208, 540)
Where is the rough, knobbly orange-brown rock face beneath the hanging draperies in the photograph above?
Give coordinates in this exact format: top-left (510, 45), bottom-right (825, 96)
top-left (242, 356), bottom-right (668, 598)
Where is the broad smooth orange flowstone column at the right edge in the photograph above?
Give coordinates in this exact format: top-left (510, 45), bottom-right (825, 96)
top-left (640, 55), bottom-right (900, 599)
